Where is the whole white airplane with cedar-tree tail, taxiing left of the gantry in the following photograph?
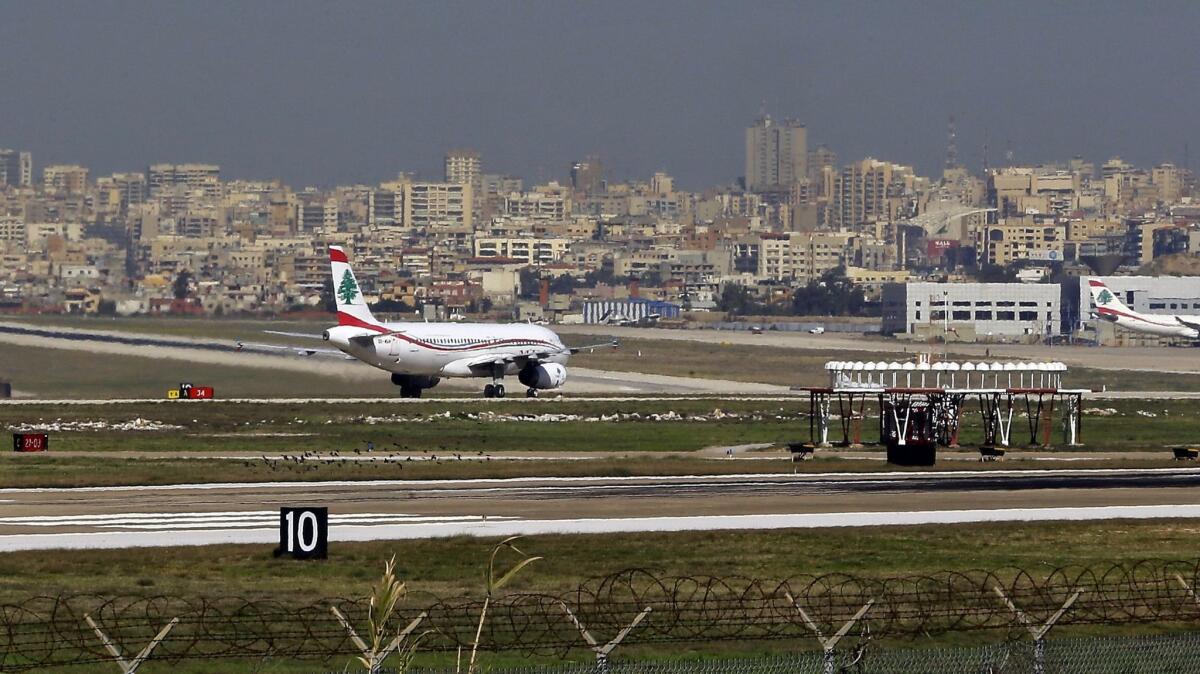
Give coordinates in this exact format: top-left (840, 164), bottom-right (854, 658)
top-left (238, 246), bottom-right (617, 398)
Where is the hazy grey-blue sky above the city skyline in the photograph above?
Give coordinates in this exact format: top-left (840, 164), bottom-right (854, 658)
top-left (0, 0), bottom-right (1200, 188)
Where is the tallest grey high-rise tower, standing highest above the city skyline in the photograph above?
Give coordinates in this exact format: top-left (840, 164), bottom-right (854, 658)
top-left (745, 115), bottom-right (809, 192)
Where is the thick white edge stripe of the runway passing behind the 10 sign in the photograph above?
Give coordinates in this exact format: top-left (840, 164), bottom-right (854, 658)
top-left (0, 505), bottom-right (1200, 554)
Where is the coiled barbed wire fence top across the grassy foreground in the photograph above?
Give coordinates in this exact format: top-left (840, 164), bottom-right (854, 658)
top-left (0, 560), bottom-right (1200, 674)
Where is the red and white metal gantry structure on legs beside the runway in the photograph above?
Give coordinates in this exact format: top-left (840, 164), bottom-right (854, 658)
top-left (803, 355), bottom-right (1090, 465)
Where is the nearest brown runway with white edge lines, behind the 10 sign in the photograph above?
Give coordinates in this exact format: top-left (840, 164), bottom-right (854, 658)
top-left (7, 469), bottom-right (1200, 552)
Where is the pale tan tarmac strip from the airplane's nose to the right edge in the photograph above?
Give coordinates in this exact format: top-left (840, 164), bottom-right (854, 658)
top-left (554, 325), bottom-right (1200, 374)
